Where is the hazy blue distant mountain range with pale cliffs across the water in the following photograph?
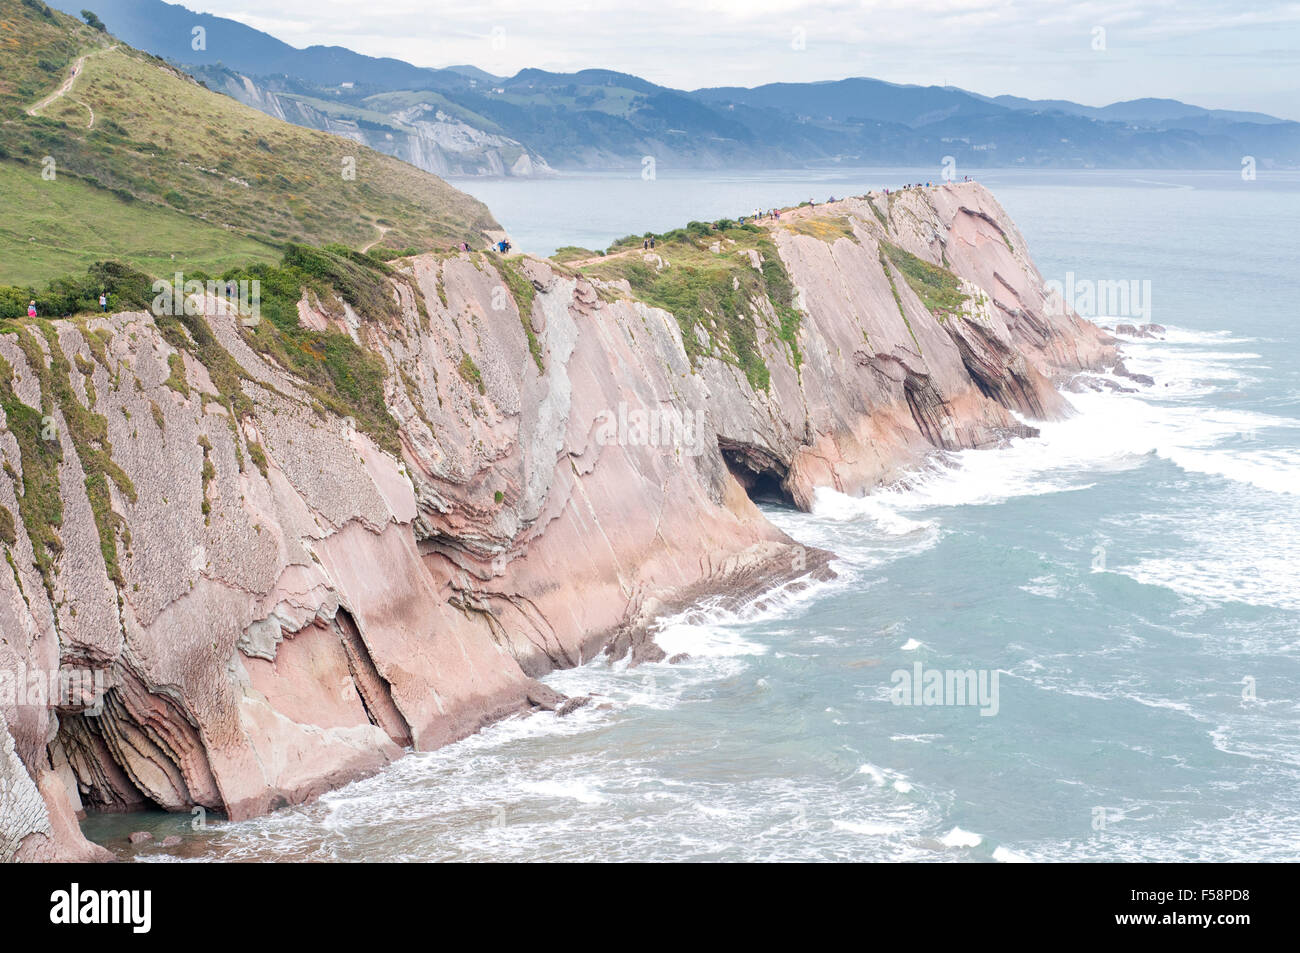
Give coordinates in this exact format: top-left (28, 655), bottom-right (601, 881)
top-left (53, 0), bottom-right (1300, 176)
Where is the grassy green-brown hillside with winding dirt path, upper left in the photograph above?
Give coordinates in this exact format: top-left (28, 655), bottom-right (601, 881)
top-left (0, 0), bottom-right (497, 283)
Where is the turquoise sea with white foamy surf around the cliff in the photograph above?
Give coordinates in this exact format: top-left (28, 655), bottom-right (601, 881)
top-left (87, 170), bottom-right (1300, 861)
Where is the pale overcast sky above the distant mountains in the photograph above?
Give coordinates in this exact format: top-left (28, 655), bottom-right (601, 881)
top-left (182, 0), bottom-right (1300, 120)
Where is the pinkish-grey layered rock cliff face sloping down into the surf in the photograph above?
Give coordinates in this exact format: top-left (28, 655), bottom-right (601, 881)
top-left (0, 185), bottom-right (1115, 861)
